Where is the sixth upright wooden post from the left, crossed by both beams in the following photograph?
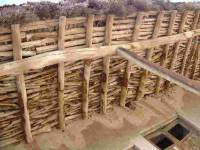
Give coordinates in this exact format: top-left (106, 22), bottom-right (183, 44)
top-left (136, 12), bottom-right (163, 99)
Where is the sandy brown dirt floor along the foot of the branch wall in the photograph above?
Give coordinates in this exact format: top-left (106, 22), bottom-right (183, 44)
top-left (3, 87), bottom-right (200, 150)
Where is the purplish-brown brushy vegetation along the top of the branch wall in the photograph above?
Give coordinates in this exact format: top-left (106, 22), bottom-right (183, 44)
top-left (0, 0), bottom-right (200, 25)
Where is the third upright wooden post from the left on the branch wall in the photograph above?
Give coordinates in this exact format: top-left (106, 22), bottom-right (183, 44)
top-left (82, 15), bottom-right (94, 119)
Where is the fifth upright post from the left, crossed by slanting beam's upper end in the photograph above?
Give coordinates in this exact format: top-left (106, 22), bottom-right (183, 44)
top-left (120, 12), bottom-right (144, 107)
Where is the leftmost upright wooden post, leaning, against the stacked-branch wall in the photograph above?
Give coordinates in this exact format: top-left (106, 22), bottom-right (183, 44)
top-left (11, 24), bottom-right (33, 143)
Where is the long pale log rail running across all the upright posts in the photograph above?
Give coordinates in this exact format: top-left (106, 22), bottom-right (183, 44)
top-left (0, 29), bottom-right (200, 76)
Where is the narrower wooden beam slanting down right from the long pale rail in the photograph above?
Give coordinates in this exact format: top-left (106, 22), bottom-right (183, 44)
top-left (117, 48), bottom-right (200, 95)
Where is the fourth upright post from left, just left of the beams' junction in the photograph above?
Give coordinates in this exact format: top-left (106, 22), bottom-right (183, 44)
top-left (101, 15), bottom-right (114, 114)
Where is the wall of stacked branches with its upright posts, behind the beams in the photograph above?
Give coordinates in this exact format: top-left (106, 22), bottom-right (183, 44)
top-left (0, 11), bottom-right (200, 147)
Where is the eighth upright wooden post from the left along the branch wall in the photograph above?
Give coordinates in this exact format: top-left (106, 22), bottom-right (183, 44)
top-left (169, 11), bottom-right (188, 71)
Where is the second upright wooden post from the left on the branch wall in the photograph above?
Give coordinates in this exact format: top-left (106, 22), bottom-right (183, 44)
top-left (58, 16), bottom-right (66, 131)
